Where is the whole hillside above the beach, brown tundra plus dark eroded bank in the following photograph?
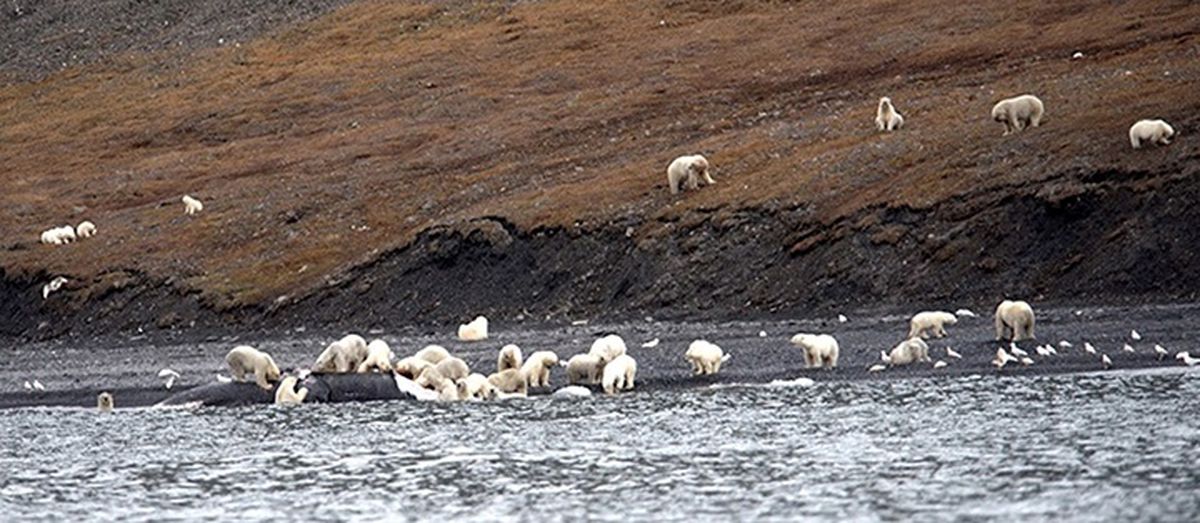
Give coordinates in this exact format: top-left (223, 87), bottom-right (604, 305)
top-left (0, 0), bottom-right (1200, 336)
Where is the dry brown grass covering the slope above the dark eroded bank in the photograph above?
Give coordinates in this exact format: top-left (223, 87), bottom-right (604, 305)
top-left (0, 0), bottom-right (1200, 305)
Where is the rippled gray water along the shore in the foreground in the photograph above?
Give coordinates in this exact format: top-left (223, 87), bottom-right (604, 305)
top-left (0, 372), bottom-right (1200, 521)
